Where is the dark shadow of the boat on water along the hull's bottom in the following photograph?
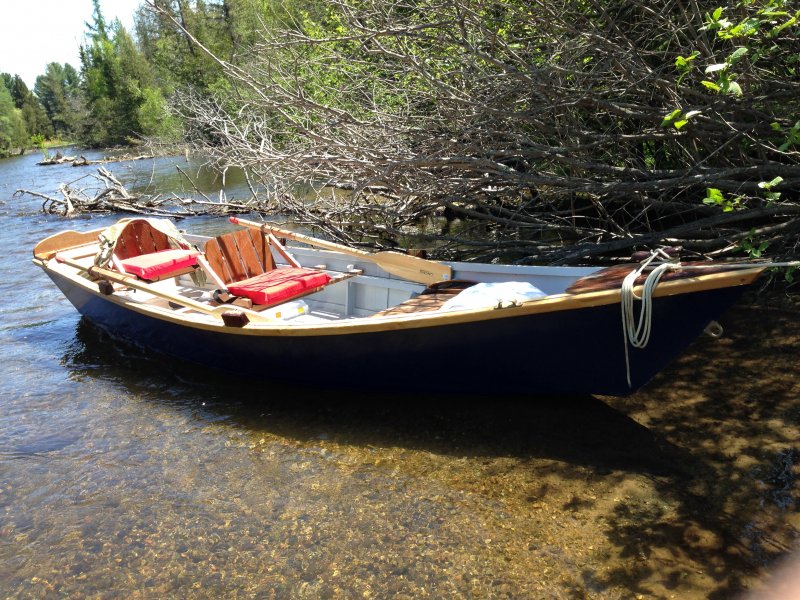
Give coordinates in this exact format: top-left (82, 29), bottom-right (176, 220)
top-left (64, 319), bottom-right (688, 476)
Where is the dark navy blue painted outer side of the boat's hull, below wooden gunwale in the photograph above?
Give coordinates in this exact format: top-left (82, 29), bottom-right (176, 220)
top-left (48, 276), bottom-right (745, 396)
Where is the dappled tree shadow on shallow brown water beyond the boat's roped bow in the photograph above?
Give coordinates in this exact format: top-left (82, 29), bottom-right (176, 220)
top-left (609, 294), bottom-right (800, 598)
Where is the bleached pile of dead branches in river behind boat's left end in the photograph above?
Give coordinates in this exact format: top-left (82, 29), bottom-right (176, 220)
top-left (14, 167), bottom-right (264, 219)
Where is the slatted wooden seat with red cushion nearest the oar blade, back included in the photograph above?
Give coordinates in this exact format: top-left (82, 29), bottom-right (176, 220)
top-left (205, 229), bottom-right (331, 307)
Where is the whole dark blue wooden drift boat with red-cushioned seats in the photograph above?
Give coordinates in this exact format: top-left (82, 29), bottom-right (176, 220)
top-left (34, 218), bottom-right (765, 395)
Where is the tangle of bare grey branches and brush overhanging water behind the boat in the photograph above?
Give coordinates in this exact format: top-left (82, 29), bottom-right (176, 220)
top-left (150, 0), bottom-right (800, 263)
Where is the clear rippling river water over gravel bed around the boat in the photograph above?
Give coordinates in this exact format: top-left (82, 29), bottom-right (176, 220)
top-left (0, 153), bottom-right (800, 599)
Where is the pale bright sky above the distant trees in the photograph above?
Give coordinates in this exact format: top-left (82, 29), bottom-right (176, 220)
top-left (0, 0), bottom-right (142, 89)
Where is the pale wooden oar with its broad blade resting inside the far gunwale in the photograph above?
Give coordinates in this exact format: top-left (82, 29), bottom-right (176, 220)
top-left (230, 217), bottom-right (453, 285)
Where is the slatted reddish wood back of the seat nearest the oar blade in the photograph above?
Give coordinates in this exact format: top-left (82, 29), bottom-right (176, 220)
top-left (205, 229), bottom-right (275, 284)
